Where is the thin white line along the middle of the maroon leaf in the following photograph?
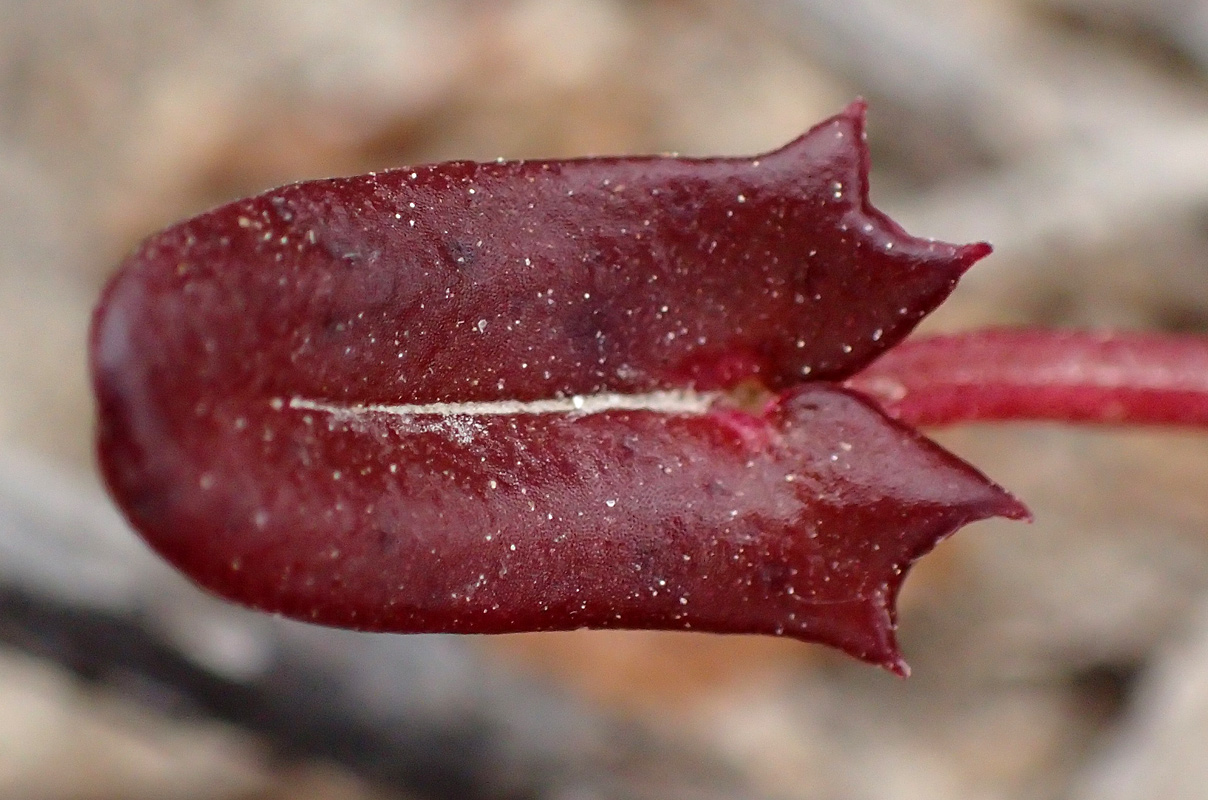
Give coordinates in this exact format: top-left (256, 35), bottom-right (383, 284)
top-left (285, 390), bottom-right (721, 417)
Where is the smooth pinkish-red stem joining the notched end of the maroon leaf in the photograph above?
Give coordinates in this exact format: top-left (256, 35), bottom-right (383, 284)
top-left (846, 329), bottom-right (1208, 425)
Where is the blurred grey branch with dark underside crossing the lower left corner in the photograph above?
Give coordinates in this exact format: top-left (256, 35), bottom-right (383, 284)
top-left (0, 454), bottom-right (754, 800)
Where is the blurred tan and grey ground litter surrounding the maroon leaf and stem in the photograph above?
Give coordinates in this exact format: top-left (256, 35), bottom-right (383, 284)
top-left (0, 0), bottom-right (1208, 800)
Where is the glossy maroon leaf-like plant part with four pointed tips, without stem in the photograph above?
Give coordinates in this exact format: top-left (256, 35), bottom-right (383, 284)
top-left (92, 103), bottom-right (1027, 672)
